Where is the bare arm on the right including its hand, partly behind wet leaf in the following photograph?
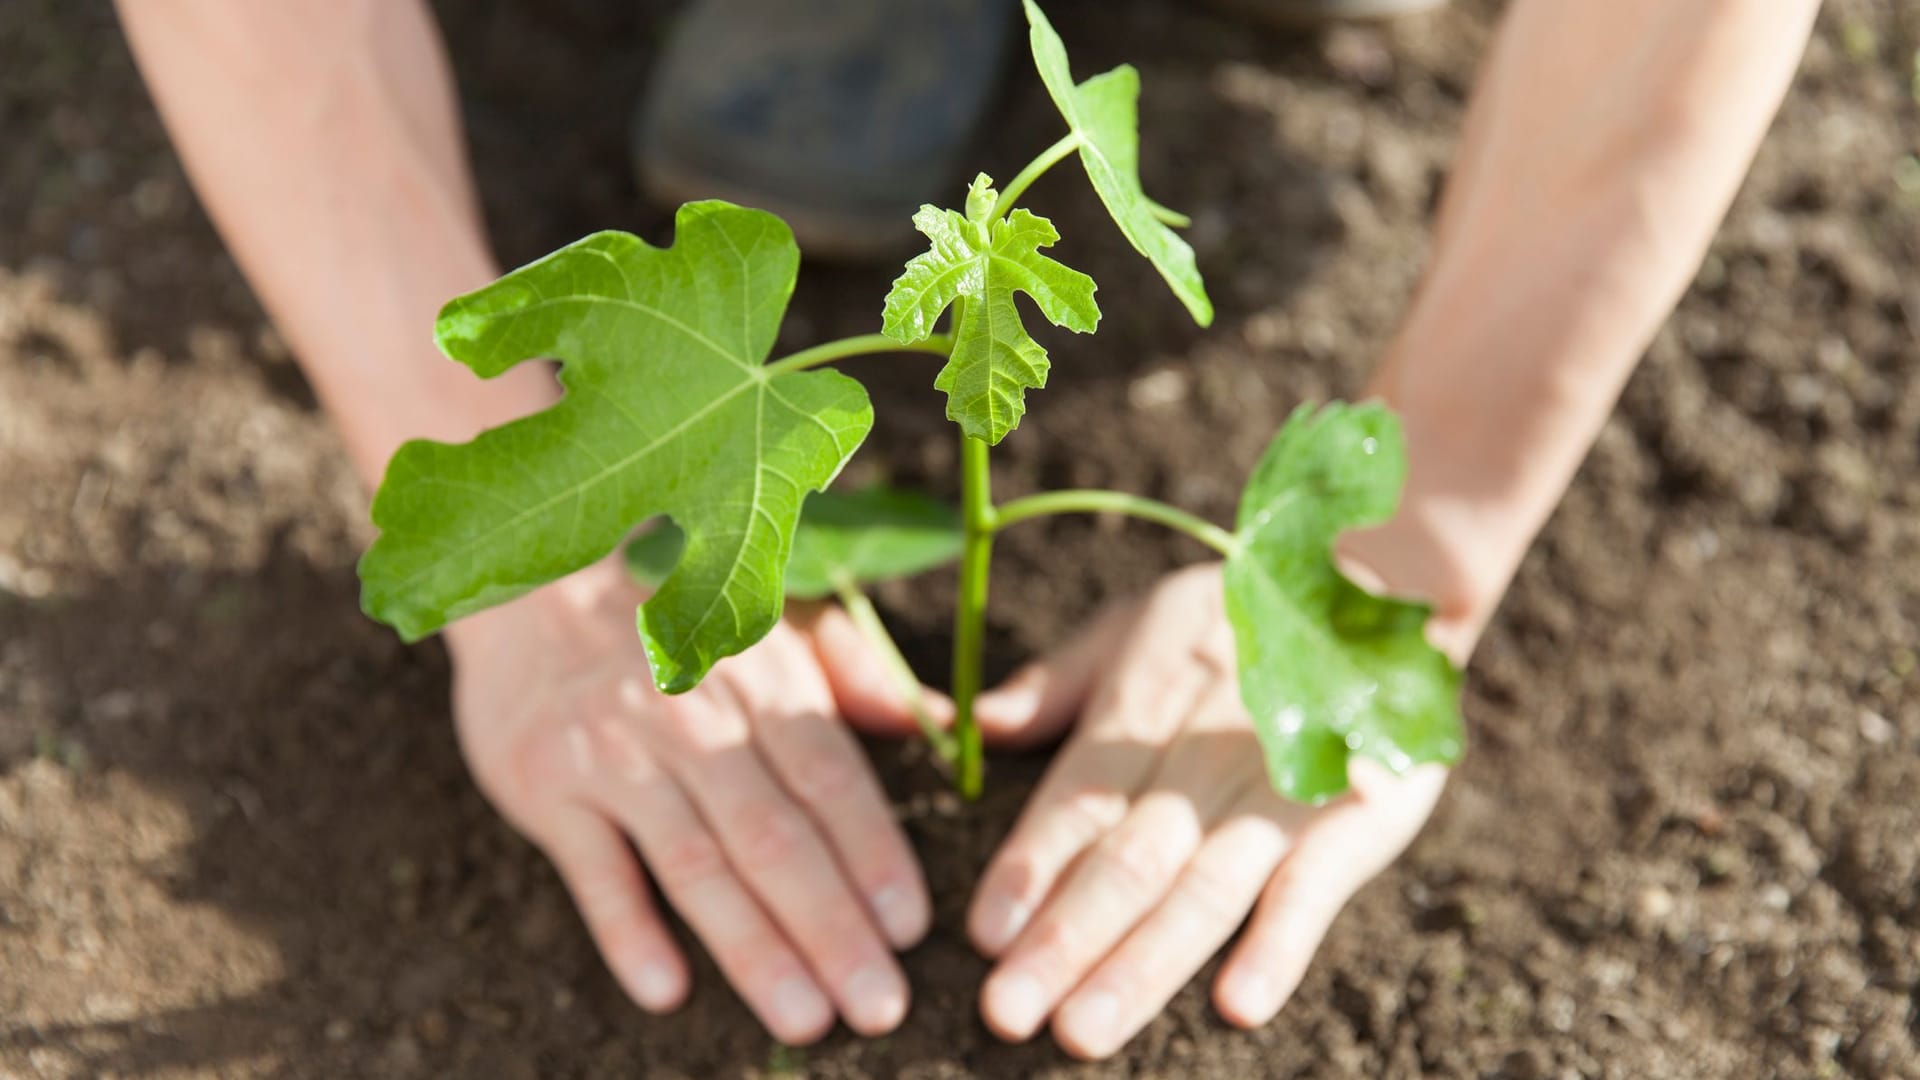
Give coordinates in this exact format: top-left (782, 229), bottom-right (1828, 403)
top-left (968, 0), bottom-right (1816, 1057)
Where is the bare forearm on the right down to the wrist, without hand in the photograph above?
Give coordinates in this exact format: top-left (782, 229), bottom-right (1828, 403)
top-left (1344, 0), bottom-right (1818, 642)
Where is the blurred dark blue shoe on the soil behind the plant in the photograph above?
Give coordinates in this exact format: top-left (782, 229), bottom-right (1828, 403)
top-left (634, 0), bottom-right (1018, 259)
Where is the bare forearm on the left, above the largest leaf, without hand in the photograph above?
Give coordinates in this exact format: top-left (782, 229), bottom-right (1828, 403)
top-left (119, 0), bottom-right (555, 486)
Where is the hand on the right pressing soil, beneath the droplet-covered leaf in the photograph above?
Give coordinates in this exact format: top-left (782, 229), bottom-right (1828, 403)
top-left (968, 565), bottom-right (1446, 1059)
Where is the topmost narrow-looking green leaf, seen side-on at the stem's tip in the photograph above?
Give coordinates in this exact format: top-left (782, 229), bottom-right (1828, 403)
top-left (1025, 0), bottom-right (1213, 327)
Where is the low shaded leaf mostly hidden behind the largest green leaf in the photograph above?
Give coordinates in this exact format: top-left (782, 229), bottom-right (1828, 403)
top-left (626, 486), bottom-right (966, 600)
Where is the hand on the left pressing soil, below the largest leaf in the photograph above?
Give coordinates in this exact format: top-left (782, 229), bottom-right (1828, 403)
top-left (447, 561), bottom-right (931, 1043)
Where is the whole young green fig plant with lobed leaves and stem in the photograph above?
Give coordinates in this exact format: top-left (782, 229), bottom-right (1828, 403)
top-left (359, 0), bottom-right (1461, 801)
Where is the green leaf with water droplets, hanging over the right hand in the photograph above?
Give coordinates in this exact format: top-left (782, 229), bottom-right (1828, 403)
top-left (1225, 404), bottom-right (1463, 803)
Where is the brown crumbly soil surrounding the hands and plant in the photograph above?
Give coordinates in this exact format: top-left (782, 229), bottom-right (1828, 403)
top-left (0, 0), bottom-right (1920, 1078)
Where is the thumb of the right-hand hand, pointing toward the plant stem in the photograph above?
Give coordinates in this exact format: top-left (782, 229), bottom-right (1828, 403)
top-left (973, 601), bottom-right (1140, 746)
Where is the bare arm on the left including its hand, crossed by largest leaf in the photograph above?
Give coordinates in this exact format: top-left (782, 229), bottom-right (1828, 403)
top-left (121, 0), bottom-right (929, 1043)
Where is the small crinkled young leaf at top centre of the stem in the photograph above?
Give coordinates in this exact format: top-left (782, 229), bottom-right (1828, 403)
top-left (881, 175), bottom-right (1100, 442)
